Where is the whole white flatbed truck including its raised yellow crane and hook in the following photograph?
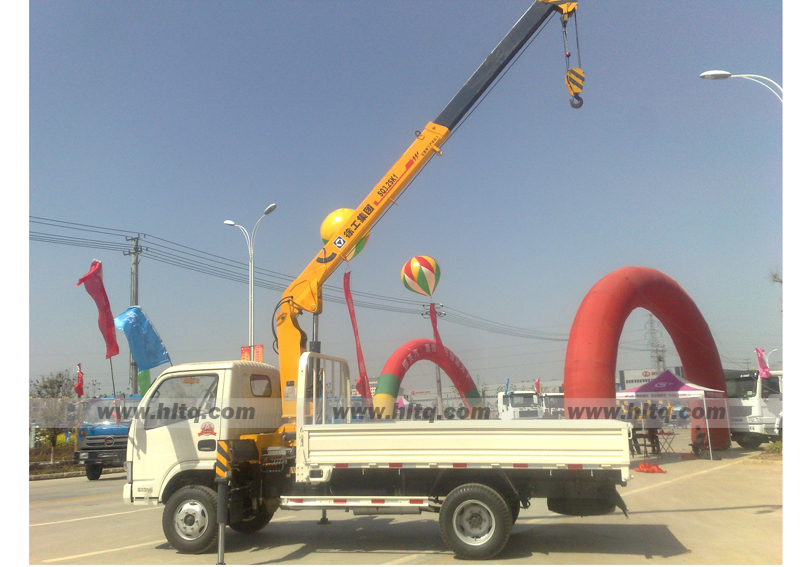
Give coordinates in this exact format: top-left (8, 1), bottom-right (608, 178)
top-left (124, 0), bottom-right (630, 563)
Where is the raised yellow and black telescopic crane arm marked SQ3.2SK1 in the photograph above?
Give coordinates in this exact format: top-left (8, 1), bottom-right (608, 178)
top-left (276, 0), bottom-right (576, 422)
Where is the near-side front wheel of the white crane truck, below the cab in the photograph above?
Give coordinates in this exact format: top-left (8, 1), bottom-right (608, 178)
top-left (161, 485), bottom-right (219, 553)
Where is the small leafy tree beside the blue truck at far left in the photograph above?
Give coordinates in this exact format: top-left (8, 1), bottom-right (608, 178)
top-left (29, 370), bottom-right (77, 462)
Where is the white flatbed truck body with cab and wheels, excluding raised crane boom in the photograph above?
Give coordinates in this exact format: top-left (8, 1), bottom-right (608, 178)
top-left (123, 353), bottom-right (630, 559)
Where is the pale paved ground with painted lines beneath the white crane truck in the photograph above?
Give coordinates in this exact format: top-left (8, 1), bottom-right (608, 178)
top-left (29, 434), bottom-right (783, 565)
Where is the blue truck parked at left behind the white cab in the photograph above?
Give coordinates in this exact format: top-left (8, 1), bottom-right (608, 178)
top-left (74, 395), bottom-right (142, 480)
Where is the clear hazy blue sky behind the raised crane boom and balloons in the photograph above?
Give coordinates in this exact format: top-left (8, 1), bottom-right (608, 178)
top-left (27, 0), bottom-right (786, 400)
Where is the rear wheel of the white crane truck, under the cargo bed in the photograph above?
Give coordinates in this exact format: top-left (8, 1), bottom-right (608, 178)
top-left (439, 484), bottom-right (513, 559)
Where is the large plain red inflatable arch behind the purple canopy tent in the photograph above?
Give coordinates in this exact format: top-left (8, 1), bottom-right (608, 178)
top-left (564, 267), bottom-right (730, 448)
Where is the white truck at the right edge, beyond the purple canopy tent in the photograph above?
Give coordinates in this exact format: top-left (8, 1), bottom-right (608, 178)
top-left (725, 370), bottom-right (783, 449)
